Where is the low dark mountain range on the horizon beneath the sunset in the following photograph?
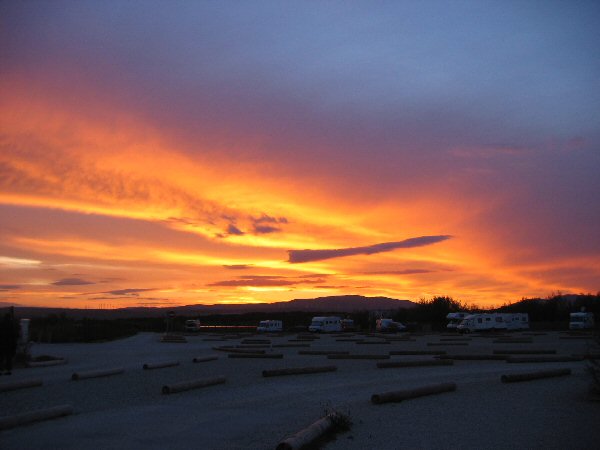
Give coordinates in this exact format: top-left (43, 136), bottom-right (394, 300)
top-left (5, 295), bottom-right (416, 319)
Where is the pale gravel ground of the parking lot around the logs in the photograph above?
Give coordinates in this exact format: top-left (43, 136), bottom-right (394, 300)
top-left (0, 332), bottom-right (600, 450)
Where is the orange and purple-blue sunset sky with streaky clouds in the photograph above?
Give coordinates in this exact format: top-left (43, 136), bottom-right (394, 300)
top-left (0, 0), bottom-right (600, 308)
